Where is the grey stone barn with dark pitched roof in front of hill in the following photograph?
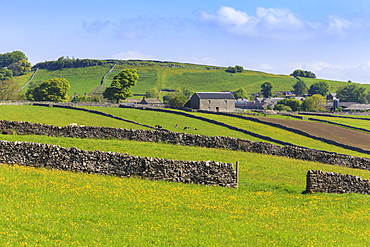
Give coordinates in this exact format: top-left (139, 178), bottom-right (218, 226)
top-left (185, 92), bottom-right (235, 112)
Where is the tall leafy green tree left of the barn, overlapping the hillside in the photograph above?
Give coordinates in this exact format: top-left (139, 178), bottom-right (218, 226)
top-left (103, 69), bottom-right (139, 103)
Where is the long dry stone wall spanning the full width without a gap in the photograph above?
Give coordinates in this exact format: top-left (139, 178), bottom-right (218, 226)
top-left (0, 120), bottom-right (370, 170)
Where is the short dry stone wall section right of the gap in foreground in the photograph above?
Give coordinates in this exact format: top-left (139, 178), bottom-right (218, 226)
top-left (305, 170), bottom-right (370, 194)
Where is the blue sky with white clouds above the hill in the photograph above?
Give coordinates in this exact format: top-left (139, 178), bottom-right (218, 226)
top-left (0, 0), bottom-right (370, 84)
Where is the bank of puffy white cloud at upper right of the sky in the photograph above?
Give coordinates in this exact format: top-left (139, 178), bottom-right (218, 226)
top-left (200, 6), bottom-right (370, 40)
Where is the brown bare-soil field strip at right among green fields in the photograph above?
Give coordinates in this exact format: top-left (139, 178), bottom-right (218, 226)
top-left (257, 117), bottom-right (370, 150)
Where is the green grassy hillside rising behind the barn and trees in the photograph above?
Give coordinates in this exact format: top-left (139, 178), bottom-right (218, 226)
top-left (13, 61), bottom-right (370, 95)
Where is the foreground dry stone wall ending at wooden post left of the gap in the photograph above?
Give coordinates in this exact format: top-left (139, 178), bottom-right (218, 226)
top-left (0, 141), bottom-right (237, 188)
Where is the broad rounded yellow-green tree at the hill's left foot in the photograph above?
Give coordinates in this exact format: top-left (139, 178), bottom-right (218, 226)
top-left (26, 78), bottom-right (71, 102)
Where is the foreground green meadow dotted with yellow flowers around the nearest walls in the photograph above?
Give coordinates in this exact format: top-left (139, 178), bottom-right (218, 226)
top-left (0, 136), bottom-right (370, 246)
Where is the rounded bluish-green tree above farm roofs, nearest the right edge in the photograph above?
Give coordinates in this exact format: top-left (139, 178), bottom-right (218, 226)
top-left (337, 84), bottom-right (366, 104)
